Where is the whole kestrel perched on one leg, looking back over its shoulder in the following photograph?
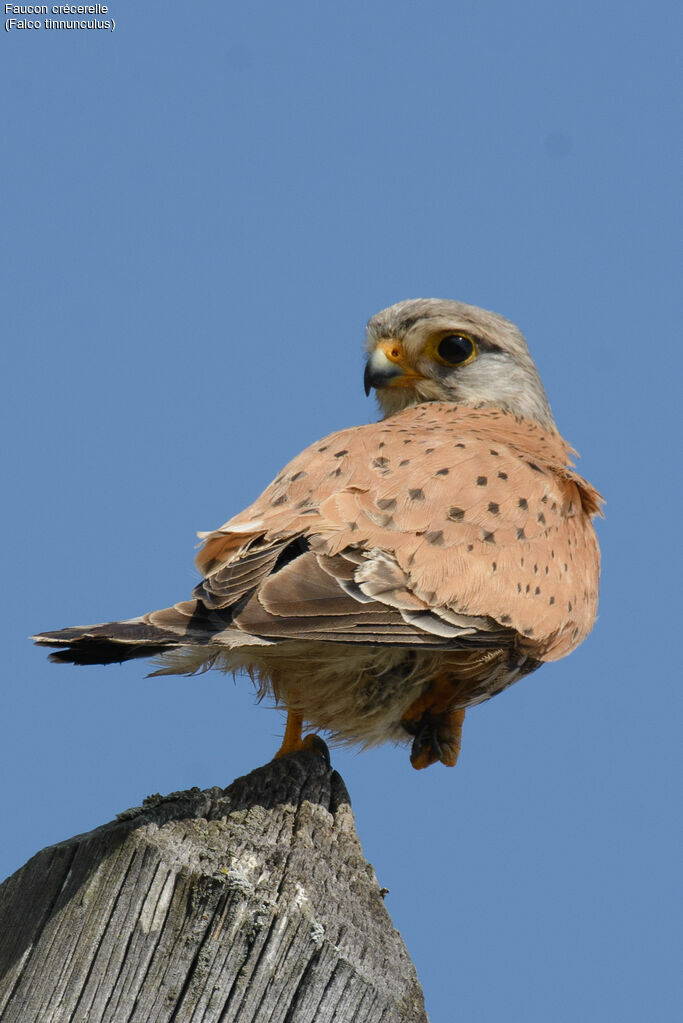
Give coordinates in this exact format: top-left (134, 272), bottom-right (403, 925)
top-left (32, 299), bottom-right (603, 769)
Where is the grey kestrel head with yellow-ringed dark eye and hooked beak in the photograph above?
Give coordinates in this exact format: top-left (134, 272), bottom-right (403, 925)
top-left (365, 299), bottom-right (554, 429)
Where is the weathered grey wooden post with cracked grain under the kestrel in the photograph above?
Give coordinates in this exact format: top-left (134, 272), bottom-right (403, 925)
top-left (0, 752), bottom-right (427, 1023)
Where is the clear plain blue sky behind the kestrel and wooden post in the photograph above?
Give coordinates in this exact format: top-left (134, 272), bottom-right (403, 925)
top-left (0, 0), bottom-right (683, 1023)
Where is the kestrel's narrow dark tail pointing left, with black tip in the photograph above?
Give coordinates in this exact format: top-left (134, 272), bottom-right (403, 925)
top-left (31, 601), bottom-right (228, 664)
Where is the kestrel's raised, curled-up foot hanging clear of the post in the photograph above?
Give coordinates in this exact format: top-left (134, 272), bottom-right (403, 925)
top-left (402, 674), bottom-right (465, 770)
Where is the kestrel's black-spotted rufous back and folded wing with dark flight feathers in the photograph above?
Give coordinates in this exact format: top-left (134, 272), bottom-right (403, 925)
top-left (195, 403), bottom-right (599, 660)
